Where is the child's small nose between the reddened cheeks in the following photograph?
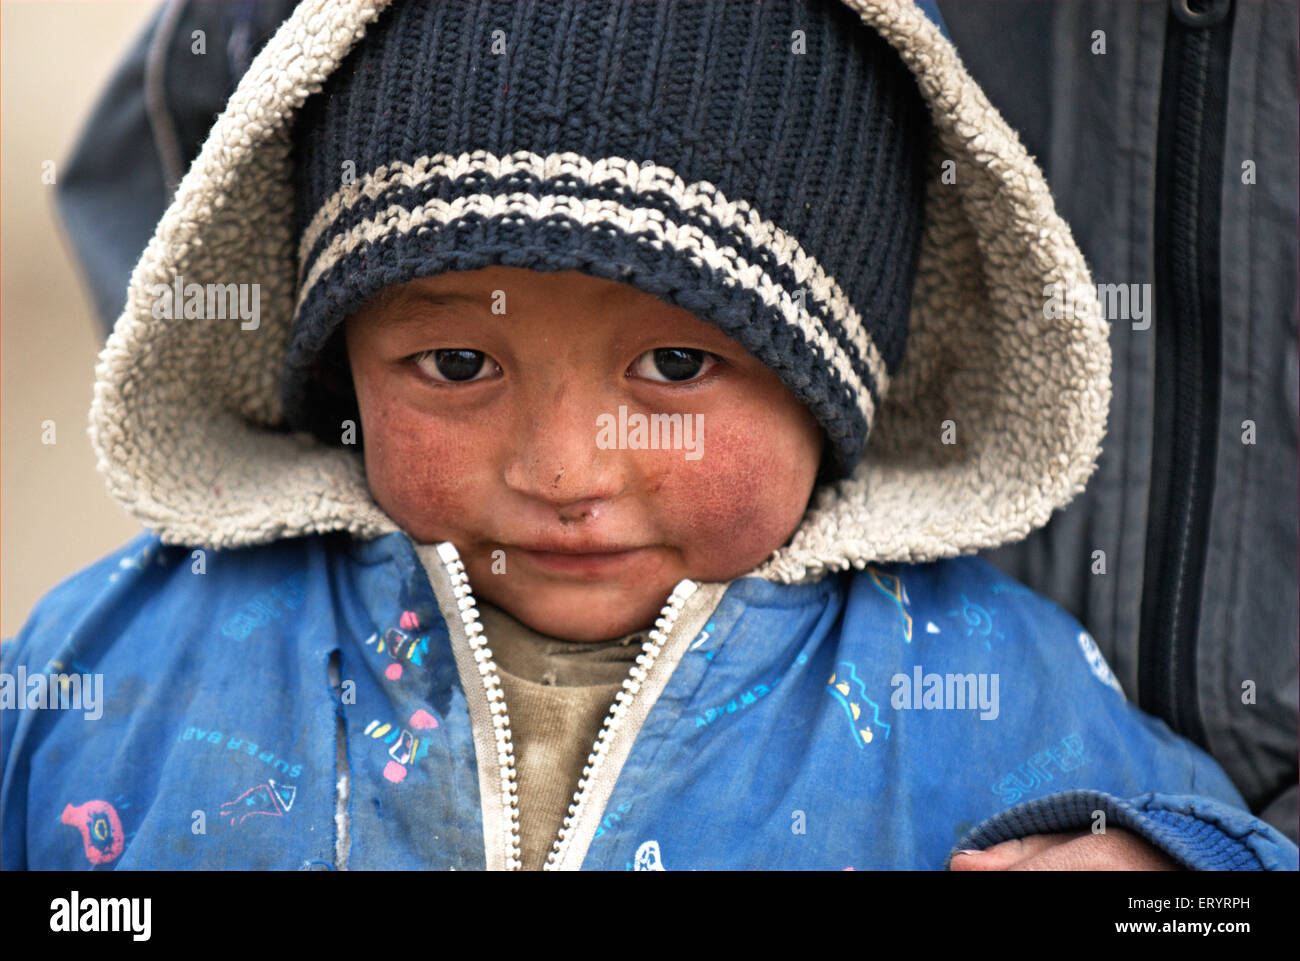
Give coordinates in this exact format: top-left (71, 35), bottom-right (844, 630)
top-left (504, 394), bottom-right (625, 520)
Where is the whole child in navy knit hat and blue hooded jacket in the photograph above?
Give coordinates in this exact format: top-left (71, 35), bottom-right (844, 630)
top-left (3, 0), bottom-right (1296, 870)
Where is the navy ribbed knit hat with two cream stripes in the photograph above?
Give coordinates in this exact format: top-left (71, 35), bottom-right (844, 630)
top-left (281, 0), bottom-right (928, 476)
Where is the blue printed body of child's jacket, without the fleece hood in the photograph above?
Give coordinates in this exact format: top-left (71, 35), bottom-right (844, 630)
top-left (0, 533), bottom-right (1297, 870)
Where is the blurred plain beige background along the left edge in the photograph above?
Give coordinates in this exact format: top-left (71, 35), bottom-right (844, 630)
top-left (0, 0), bottom-right (157, 637)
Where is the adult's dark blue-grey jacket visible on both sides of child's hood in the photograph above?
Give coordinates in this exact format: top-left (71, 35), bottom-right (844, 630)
top-left (56, 0), bottom-right (1300, 840)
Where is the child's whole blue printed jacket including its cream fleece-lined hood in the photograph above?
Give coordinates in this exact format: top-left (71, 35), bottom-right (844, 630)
top-left (0, 1), bottom-right (1296, 869)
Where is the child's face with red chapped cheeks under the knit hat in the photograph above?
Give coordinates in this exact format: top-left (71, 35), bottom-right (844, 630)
top-left (346, 267), bottom-right (822, 641)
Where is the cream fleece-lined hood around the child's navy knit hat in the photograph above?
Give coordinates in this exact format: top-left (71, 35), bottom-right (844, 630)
top-left (91, 0), bottom-right (1110, 583)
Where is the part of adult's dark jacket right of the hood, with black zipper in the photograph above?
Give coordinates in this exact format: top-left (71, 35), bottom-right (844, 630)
top-left (939, 0), bottom-right (1300, 839)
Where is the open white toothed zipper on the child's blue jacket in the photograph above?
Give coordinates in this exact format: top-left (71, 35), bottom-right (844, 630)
top-left (438, 541), bottom-right (698, 871)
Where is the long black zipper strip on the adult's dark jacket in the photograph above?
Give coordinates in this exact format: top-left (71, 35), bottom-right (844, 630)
top-left (1139, 0), bottom-right (1232, 744)
